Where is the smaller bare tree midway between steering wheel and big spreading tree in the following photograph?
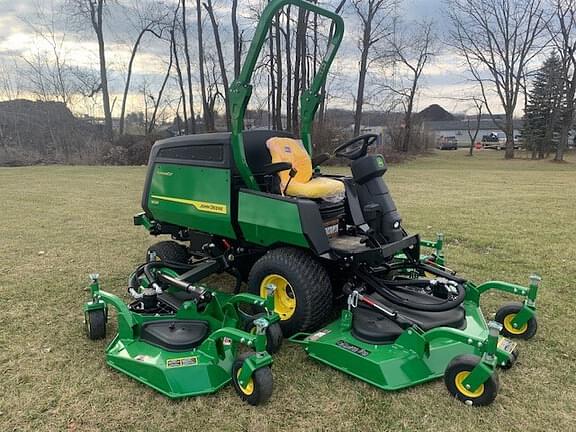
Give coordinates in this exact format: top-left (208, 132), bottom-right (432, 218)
top-left (385, 22), bottom-right (436, 152)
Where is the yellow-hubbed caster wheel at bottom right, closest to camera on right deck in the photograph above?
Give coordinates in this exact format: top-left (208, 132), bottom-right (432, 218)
top-left (444, 354), bottom-right (498, 406)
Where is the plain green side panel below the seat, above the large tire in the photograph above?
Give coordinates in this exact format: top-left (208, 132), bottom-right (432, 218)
top-left (238, 191), bottom-right (309, 247)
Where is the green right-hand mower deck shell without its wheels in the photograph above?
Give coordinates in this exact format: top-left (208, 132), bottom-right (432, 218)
top-left (290, 301), bottom-right (516, 390)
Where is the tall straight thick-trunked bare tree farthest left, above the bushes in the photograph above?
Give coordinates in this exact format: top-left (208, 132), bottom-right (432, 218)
top-left (68, 0), bottom-right (113, 141)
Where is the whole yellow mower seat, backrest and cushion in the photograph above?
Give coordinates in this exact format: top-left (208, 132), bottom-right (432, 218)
top-left (266, 137), bottom-right (344, 201)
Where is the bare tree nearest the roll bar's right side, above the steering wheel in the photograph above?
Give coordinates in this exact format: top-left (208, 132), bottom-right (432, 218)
top-left (352, 0), bottom-right (395, 135)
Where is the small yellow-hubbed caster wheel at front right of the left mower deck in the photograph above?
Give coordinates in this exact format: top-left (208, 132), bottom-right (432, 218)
top-left (232, 351), bottom-right (273, 406)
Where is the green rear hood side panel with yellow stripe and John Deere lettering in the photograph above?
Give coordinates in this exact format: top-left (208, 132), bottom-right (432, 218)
top-left (147, 163), bottom-right (236, 238)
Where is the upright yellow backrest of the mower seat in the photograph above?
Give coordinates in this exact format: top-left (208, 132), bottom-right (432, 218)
top-left (266, 137), bottom-right (313, 185)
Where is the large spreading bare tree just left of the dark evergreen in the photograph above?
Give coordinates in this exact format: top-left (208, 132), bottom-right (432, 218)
top-left (447, 0), bottom-right (548, 159)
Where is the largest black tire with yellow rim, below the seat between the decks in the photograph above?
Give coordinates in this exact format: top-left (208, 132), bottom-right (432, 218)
top-left (248, 247), bottom-right (333, 337)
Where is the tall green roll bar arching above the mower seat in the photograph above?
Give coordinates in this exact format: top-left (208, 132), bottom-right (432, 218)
top-left (228, 0), bottom-right (344, 190)
